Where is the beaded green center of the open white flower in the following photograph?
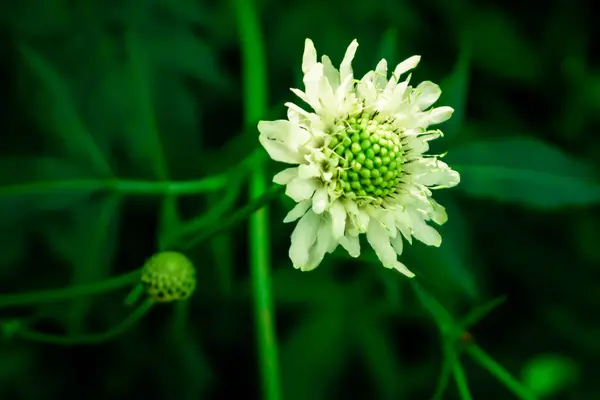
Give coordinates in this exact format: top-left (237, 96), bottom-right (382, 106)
top-left (328, 116), bottom-right (404, 200)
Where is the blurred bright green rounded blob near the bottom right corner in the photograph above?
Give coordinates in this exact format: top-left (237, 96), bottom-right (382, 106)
top-left (521, 354), bottom-right (579, 399)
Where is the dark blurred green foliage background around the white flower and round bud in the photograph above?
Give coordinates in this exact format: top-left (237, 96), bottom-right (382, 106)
top-left (0, 0), bottom-right (600, 400)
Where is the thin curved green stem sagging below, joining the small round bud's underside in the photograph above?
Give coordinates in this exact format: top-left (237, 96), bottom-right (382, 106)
top-left (15, 300), bottom-right (154, 346)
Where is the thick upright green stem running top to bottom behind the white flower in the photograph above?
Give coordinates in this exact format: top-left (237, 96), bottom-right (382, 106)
top-left (234, 0), bottom-right (280, 400)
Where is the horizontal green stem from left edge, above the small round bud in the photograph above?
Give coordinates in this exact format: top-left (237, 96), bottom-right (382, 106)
top-left (0, 174), bottom-right (228, 197)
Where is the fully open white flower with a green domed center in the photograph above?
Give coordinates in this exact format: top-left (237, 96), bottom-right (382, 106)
top-left (258, 39), bottom-right (460, 277)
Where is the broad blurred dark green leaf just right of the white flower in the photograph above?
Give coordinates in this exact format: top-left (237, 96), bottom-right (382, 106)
top-left (447, 138), bottom-right (600, 208)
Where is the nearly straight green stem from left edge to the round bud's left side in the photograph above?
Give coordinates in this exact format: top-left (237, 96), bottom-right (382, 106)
top-left (0, 270), bottom-right (140, 308)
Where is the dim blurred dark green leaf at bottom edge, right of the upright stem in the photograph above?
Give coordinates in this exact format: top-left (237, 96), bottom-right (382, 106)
top-left (281, 310), bottom-right (348, 400)
